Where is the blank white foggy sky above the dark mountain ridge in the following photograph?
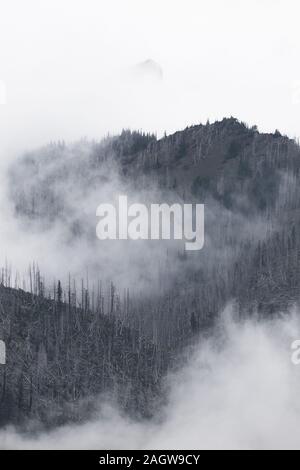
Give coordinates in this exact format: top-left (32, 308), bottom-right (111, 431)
top-left (0, 0), bottom-right (300, 156)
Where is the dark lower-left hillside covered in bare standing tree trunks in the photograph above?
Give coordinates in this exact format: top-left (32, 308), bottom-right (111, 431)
top-left (0, 284), bottom-right (165, 425)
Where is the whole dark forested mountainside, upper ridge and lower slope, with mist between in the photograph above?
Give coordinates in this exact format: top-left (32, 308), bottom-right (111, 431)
top-left (0, 118), bottom-right (300, 424)
